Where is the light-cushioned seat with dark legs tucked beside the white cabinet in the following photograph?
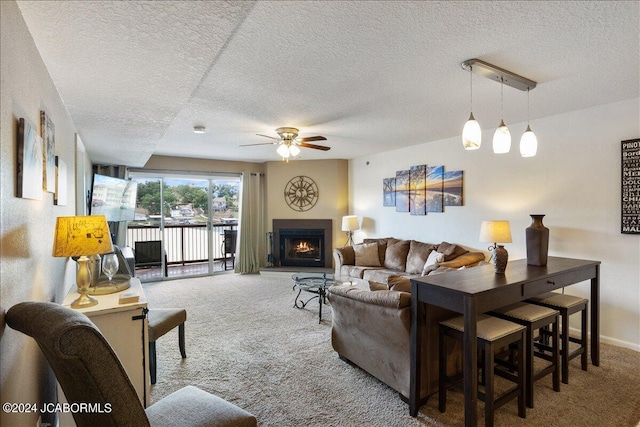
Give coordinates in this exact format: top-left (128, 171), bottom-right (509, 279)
top-left (147, 308), bottom-right (187, 384)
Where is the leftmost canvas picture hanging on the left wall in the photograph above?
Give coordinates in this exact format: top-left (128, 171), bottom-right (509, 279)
top-left (16, 118), bottom-right (43, 200)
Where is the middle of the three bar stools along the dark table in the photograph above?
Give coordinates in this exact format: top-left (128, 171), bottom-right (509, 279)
top-left (491, 303), bottom-right (560, 408)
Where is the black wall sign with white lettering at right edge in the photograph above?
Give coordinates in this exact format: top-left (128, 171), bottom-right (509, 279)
top-left (620, 139), bottom-right (640, 234)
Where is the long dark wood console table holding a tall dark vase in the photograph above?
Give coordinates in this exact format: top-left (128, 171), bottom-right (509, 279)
top-left (409, 257), bottom-right (600, 426)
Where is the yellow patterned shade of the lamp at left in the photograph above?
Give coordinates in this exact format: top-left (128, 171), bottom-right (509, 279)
top-left (53, 215), bottom-right (113, 257)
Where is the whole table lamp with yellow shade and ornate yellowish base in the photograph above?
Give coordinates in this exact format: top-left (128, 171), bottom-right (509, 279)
top-left (53, 215), bottom-right (113, 308)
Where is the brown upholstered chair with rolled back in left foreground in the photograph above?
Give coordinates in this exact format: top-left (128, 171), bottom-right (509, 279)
top-left (5, 302), bottom-right (257, 427)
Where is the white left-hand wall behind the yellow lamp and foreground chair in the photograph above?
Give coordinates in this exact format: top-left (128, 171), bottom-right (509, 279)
top-left (0, 1), bottom-right (76, 426)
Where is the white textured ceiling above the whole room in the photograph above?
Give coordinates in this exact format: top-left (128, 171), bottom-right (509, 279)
top-left (18, 1), bottom-right (640, 167)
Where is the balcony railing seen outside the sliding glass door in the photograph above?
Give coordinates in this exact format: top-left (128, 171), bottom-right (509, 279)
top-left (127, 223), bottom-right (237, 265)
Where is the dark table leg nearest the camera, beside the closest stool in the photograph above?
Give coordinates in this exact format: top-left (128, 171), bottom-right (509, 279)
top-left (462, 297), bottom-right (478, 427)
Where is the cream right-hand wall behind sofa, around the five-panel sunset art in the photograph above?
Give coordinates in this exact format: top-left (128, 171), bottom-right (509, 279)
top-left (349, 98), bottom-right (640, 351)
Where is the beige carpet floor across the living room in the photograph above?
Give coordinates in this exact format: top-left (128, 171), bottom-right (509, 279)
top-left (144, 273), bottom-right (640, 427)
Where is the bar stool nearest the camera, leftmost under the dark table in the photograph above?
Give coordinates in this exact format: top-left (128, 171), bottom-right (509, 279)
top-left (438, 314), bottom-right (527, 426)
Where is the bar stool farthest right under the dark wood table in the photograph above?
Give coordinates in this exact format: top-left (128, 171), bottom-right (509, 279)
top-left (527, 292), bottom-right (589, 384)
